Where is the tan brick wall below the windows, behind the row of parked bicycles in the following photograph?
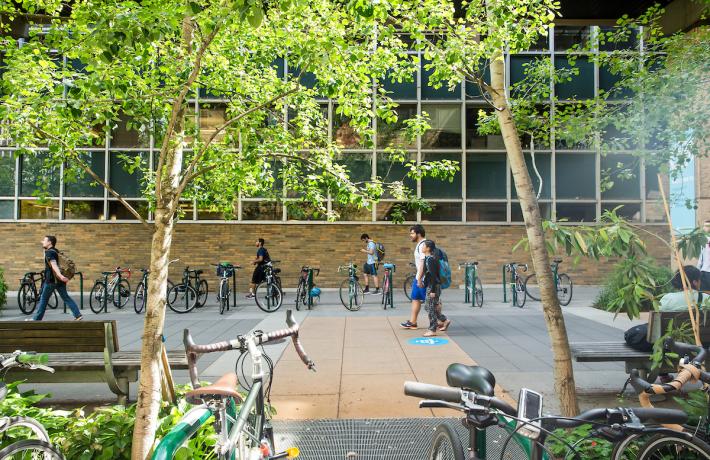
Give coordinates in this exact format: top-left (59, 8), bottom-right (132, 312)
top-left (0, 223), bottom-right (670, 290)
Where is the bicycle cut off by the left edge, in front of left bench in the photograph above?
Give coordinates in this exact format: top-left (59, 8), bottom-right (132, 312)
top-left (0, 350), bottom-right (64, 460)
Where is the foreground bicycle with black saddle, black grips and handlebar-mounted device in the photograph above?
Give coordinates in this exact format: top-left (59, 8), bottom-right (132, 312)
top-left (404, 363), bottom-right (707, 460)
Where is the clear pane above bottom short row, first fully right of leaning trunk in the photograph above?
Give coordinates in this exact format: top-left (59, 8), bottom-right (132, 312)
top-left (555, 153), bottom-right (596, 199)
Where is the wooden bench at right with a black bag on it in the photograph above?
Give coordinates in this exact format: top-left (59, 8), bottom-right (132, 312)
top-left (570, 311), bottom-right (710, 379)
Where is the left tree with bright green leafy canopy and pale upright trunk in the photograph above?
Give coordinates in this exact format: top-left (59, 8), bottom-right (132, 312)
top-left (0, 0), bottom-right (456, 459)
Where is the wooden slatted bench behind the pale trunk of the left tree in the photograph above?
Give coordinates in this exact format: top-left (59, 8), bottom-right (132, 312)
top-left (0, 320), bottom-right (187, 404)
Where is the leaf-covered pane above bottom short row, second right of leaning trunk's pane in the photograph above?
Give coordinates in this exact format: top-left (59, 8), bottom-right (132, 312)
top-left (601, 154), bottom-right (641, 200)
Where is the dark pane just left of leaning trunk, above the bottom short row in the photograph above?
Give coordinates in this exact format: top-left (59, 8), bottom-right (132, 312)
top-left (466, 153), bottom-right (507, 198)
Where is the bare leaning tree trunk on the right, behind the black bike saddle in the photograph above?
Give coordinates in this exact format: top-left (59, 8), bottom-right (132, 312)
top-left (490, 55), bottom-right (579, 416)
